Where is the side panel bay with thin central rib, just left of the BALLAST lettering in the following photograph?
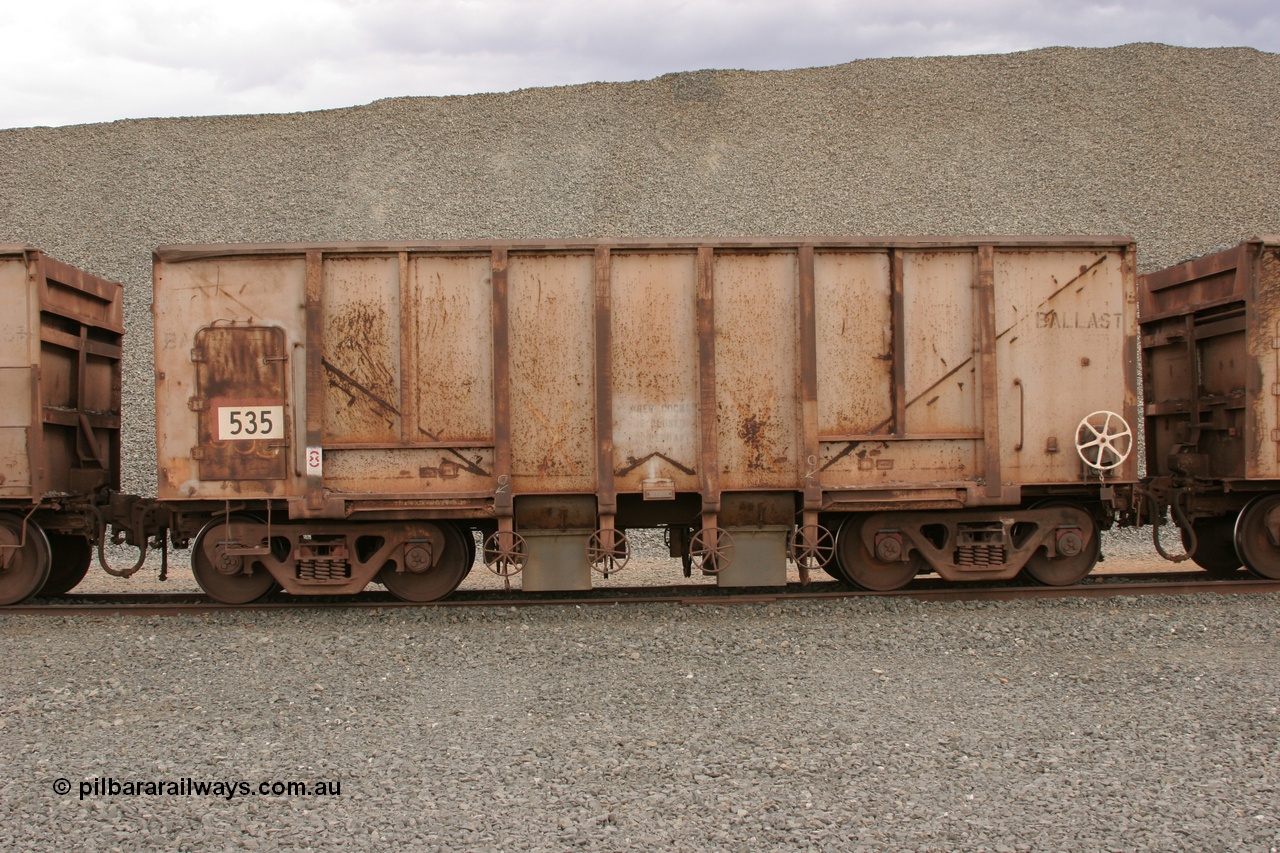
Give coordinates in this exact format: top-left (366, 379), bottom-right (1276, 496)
top-left (814, 247), bottom-right (982, 489)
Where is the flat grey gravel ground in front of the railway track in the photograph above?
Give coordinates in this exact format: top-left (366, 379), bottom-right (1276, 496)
top-left (0, 596), bottom-right (1280, 852)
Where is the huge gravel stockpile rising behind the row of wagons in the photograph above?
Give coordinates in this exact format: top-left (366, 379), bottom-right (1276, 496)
top-left (0, 45), bottom-right (1280, 494)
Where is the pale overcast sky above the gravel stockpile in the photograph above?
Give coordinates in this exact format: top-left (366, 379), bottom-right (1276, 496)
top-left (0, 0), bottom-right (1280, 128)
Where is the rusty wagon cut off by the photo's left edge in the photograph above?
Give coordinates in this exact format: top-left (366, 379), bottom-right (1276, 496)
top-left (0, 245), bottom-right (124, 605)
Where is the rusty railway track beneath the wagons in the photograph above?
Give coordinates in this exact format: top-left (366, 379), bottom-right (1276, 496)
top-left (10, 571), bottom-right (1280, 616)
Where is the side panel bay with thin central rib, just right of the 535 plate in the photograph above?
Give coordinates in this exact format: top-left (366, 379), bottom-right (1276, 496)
top-left (323, 252), bottom-right (493, 498)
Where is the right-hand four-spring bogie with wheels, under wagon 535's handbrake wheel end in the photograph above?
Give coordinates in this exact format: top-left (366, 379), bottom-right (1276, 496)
top-left (837, 503), bottom-right (1100, 590)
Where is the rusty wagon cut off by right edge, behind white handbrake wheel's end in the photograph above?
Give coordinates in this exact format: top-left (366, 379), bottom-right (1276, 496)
top-left (1138, 237), bottom-right (1280, 578)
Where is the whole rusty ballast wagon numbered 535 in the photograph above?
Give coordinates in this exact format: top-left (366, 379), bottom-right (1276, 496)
top-left (154, 238), bottom-right (1137, 602)
